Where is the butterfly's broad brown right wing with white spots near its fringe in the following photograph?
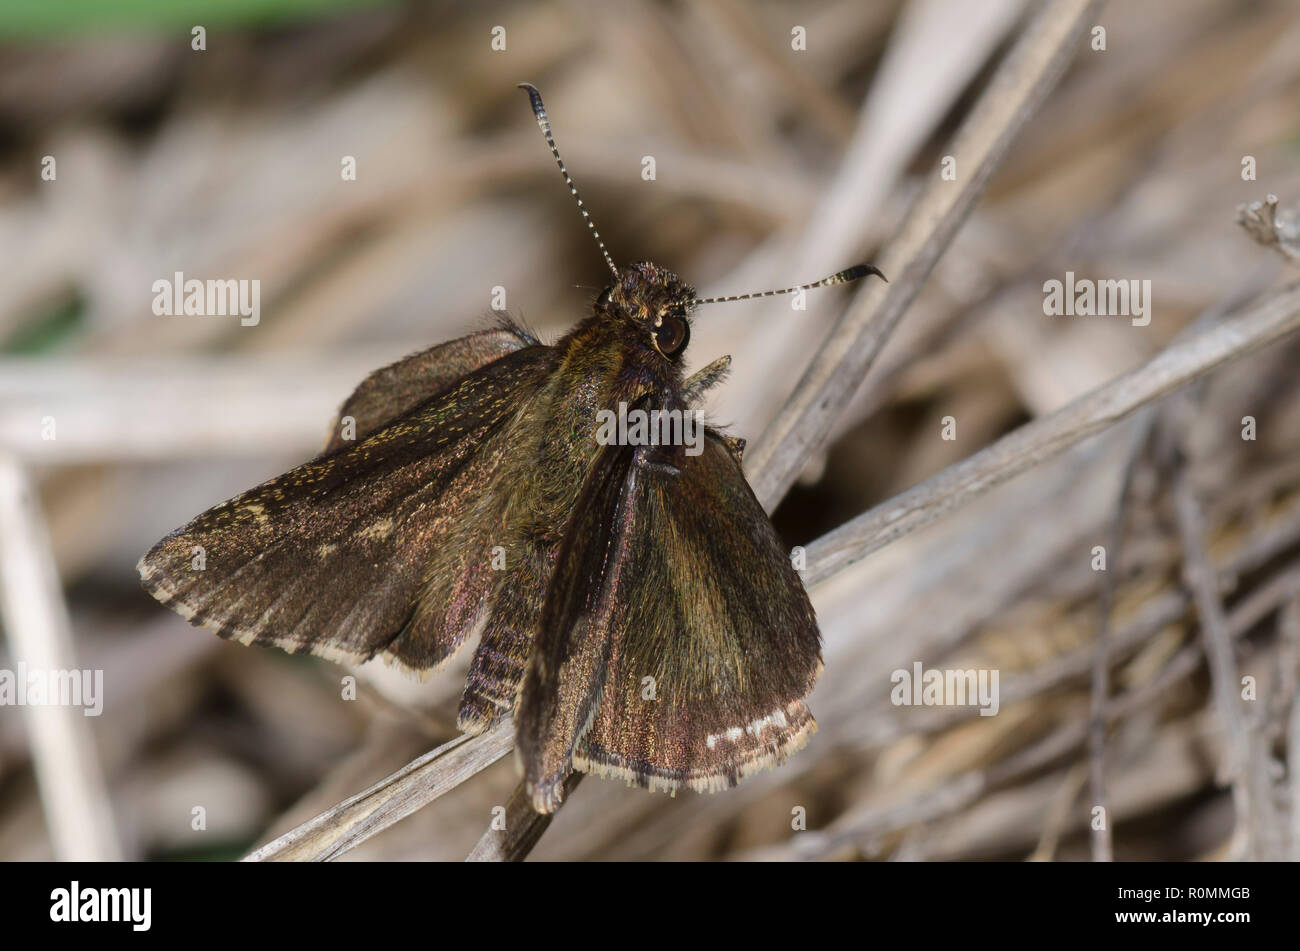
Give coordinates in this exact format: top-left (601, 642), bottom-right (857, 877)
top-left (573, 431), bottom-right (822, 791)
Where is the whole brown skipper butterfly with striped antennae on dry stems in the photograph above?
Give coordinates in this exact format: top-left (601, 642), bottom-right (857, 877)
top-left (139, 84), bottom-right (883, 812)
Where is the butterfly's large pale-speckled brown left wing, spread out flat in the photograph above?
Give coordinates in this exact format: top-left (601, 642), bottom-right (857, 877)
top-left (139, 346), bottom-right (554, 672)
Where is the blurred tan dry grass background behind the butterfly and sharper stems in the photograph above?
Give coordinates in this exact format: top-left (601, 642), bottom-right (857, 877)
top-left (0, 0), bottom-right (1300, 860)
